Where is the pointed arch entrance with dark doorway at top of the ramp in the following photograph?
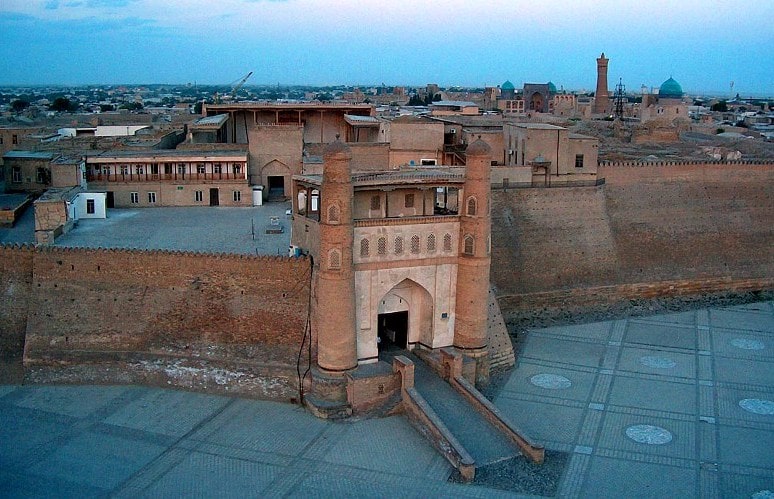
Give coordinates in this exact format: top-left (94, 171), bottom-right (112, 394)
top-left (376, 279), bottom-right (433, 353)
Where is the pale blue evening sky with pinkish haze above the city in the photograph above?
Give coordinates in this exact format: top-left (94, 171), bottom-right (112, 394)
top-left (0, 0), bottom-right (774, 96)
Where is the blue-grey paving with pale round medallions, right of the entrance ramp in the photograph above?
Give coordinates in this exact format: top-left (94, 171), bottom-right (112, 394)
top-left (495, 302), bottom-right (774, 498)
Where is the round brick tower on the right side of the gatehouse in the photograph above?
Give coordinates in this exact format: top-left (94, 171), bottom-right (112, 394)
top-left (454, 137), bottom-right (492, 380)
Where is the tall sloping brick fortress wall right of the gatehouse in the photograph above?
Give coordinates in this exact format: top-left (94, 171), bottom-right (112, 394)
top-left (492, 164), bottom-right (774, 316)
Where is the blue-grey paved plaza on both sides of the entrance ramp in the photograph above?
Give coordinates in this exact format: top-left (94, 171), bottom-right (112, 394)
top-left (0, 302), bottom-right (774, 499)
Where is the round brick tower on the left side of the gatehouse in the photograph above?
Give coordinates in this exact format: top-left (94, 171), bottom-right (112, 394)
top-left (312, 137), bottom-right (357, 373)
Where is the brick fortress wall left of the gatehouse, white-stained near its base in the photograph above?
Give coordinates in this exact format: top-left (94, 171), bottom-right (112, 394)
top-left (0, 247), bottom-right (309, 398)
